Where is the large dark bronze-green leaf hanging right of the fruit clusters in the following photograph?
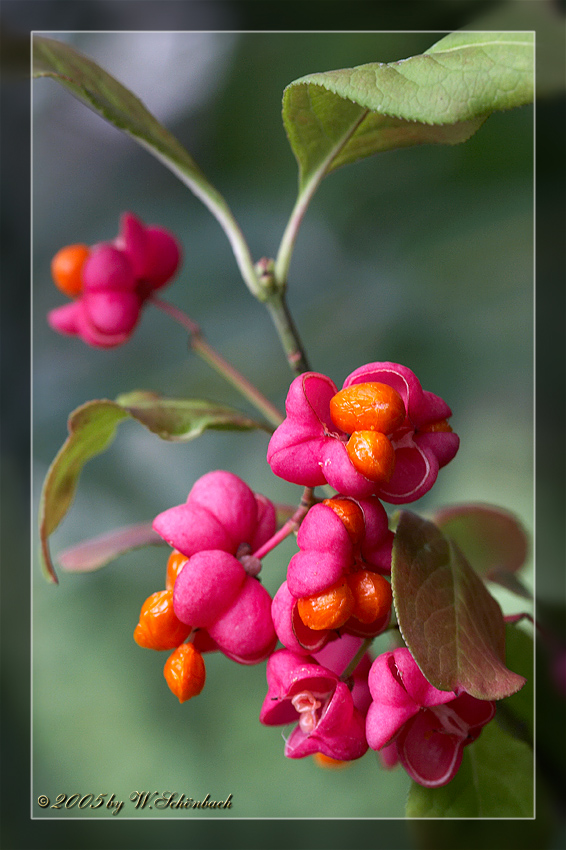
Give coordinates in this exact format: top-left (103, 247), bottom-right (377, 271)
top-left (391, 511), bottom-right (525, 700)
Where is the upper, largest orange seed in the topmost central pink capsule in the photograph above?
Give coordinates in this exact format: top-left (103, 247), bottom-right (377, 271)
top-left (330, 381), bottom-right (405, 434)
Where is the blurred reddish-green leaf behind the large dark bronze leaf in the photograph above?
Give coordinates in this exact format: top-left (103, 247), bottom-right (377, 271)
top-left (432, 504), bottom-right (531, 599)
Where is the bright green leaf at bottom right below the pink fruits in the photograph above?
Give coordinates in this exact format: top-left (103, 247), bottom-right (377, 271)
top-left (406, 722), bottom-right (534, 818)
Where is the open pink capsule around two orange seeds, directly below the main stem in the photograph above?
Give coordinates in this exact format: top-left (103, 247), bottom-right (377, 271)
top-left (267, 362), bottom-right (459, 504)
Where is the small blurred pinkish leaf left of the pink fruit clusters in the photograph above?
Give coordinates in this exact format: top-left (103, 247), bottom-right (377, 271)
top-left (57, 522), bottom-right (165, 573)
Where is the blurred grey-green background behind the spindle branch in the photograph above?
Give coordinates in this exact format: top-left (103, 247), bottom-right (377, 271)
top-left (2, 4), bottom-right (560, 848)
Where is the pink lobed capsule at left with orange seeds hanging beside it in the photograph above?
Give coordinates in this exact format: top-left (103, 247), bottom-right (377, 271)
top-left (153, 470), bottom-right (277, 664)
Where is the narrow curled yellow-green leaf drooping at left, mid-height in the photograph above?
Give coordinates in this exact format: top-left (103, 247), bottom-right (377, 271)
top-left (39, 392), bottom-right (269, 581)
